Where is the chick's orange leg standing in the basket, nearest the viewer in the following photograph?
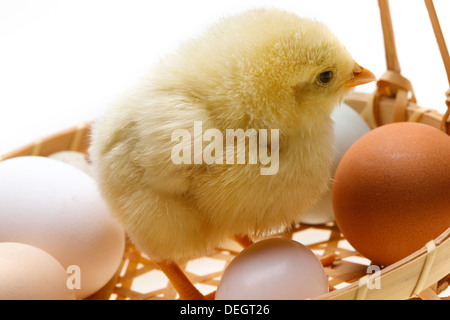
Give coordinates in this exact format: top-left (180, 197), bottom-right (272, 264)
top-left (156, 260), bottom-right (205, 300)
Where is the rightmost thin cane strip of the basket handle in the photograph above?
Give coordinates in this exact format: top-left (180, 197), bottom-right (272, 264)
top-left (425, 0), bottom-right (450, 134)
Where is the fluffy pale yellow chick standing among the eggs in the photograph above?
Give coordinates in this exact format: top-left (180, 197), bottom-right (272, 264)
top-left (90, 9), bottom-right (375, 298)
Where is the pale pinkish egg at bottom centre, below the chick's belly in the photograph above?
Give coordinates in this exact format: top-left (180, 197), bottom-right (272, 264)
top-left (215, 238), bottom-right (328, 300)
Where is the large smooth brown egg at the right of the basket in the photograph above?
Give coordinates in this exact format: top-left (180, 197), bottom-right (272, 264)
top-left (332, 122), bottom-right (450, 266)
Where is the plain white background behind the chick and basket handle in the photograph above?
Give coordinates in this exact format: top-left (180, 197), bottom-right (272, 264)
top-left (0, 0), bottom-right (450, 154)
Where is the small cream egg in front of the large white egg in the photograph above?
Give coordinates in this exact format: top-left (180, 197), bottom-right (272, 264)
top-left (0, 242), bottom-right (75, 300)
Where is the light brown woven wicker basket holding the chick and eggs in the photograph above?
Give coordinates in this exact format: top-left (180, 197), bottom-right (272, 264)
top-left (0, 0), bottom-right (450, 299)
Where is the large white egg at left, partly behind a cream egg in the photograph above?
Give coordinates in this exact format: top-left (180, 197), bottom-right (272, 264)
top-left (0, 156), bottom-right (125, 298)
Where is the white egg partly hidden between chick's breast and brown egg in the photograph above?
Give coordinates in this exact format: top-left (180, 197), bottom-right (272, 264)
top-left (300, 103), bottom-right (370, 225)
